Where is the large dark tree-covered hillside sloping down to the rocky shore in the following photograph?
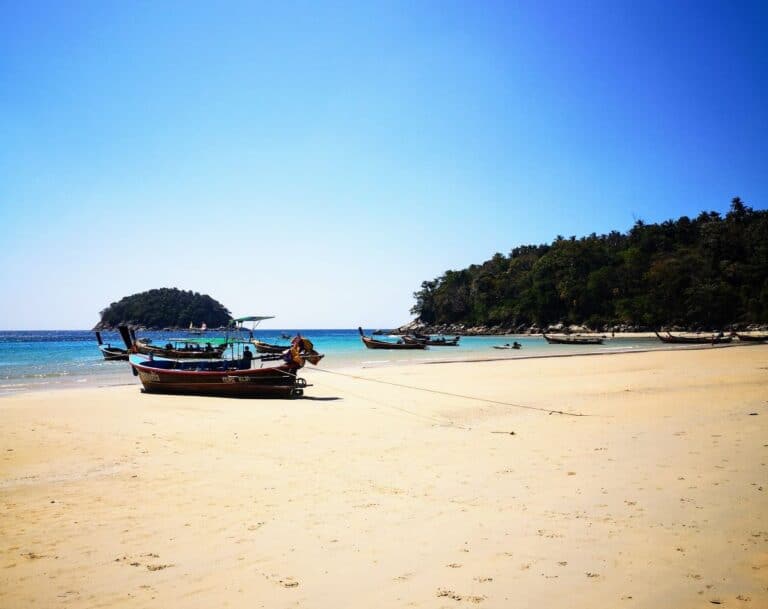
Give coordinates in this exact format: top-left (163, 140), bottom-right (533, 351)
top-left (411, 197), bottom-right (768, 328)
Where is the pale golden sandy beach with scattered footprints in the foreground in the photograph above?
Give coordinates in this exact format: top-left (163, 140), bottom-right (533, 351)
top-left (0, 346), bottom-right (768, 609)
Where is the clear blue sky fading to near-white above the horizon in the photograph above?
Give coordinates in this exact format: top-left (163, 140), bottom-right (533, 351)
top-left (0, 0), bottom-right (768, 329)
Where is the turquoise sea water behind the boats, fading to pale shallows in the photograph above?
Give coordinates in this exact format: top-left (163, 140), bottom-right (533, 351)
top-left (0, 329), bottom-right (669, 396)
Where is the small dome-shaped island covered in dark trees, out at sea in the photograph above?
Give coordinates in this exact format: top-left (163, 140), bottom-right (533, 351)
top-left (99, 288), bottom-right (232, 329)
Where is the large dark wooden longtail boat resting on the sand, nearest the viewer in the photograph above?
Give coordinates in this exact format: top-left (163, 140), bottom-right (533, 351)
top-left (129, 336), bottom-right (323, 398)
